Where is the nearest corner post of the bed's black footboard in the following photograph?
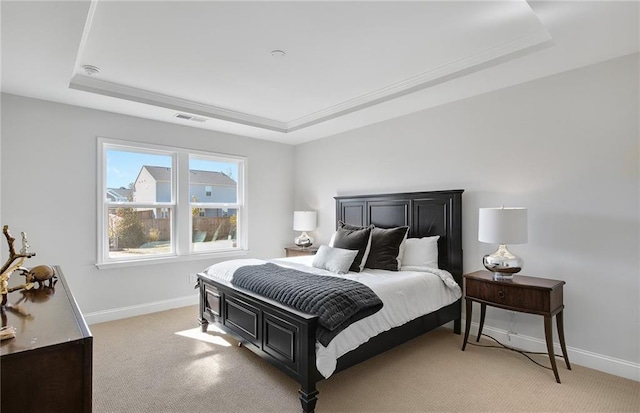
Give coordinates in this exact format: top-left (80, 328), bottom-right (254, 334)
top-left (298, 318), bottom-right (319, 413)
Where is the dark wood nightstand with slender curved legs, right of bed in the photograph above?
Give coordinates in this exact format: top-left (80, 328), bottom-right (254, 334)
top-left (462, 271), bottom-right (571, 383)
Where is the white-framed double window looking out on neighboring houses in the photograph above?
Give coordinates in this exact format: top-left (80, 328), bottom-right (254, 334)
top-left (97, 138), bottom-right (246, 267)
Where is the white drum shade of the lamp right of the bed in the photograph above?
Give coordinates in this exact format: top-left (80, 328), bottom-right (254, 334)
top-left (478, 208), bottom-right (528, 244)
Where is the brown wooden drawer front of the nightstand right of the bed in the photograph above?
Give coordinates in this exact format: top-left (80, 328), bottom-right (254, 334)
top-left (465, 278), bottom-right (551, 313)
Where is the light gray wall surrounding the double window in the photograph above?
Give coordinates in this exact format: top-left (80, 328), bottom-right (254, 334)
top-left (0, 94), bottom-right (293, 316)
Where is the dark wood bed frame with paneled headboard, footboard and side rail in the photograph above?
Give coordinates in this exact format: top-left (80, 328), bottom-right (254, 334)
top-left (198, 190), bottom-right (463, 413)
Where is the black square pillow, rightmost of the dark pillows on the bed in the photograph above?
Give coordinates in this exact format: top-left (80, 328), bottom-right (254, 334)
top-left (365, 227), bottom-right (409, 271)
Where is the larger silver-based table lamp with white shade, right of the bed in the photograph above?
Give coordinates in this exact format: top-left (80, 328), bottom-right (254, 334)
top-left (478, 207), bottom-right (527, 280)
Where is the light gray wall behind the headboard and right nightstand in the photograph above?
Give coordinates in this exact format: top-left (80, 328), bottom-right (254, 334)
top-left (295, 54), bottom-right (640, 379)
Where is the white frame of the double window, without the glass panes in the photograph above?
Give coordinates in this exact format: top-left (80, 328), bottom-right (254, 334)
top-left (96, 137), bottom-right (248, 269)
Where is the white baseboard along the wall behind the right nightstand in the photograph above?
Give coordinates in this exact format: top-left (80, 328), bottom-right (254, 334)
top-left (462, 320), bottom-right (640, 381)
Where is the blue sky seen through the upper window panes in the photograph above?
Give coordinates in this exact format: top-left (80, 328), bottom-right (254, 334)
top-left (107, 149), bottom-right (238, 188)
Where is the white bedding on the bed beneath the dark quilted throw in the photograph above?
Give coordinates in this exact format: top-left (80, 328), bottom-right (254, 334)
top-left (205, 256), bottom-right (462, 378)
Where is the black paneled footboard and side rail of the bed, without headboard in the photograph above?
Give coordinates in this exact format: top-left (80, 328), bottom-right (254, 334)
top-left (198, 274), bottom-right (461, 413)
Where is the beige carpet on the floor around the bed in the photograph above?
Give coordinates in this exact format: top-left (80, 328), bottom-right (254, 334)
top-left (90, 307), bottom-right (640, 413)
